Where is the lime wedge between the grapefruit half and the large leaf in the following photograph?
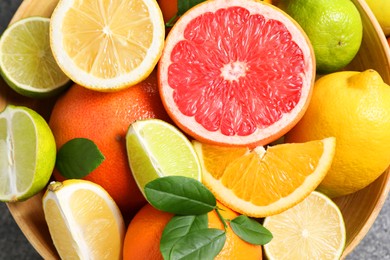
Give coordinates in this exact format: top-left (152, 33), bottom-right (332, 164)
top-left (126, 119), bottom-right (201, 196)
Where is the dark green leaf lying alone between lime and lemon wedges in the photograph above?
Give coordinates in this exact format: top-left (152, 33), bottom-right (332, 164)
top-left (56, 138), bottom-right (105, 179)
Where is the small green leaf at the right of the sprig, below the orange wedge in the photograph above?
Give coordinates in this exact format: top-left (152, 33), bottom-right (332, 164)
top-left (230, 215), bottom-right (272, 245)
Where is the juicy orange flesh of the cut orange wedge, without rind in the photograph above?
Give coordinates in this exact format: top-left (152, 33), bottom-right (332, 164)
top-left (202, 141), bottom-right (323, 206)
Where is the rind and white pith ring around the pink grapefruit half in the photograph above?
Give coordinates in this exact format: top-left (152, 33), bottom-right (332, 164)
top-left (158, 0), bottom-right (315, 147)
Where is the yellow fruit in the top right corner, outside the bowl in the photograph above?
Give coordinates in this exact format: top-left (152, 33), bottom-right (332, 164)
top-left (366, 0), bottom-right (390, 36)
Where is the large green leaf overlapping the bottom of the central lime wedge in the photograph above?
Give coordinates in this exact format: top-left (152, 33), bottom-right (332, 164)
top-left (145, 176), bottom-right (217, 215)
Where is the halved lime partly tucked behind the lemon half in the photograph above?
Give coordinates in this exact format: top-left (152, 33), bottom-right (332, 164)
top-left (0, 16), bottom-right (70, 97)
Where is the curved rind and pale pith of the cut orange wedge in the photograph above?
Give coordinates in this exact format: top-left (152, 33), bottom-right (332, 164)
top-left (193, 137), bottom-right (336, 218)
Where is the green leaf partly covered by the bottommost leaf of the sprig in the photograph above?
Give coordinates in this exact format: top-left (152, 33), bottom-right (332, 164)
top-left (160, 214), bottom-right (208, 259)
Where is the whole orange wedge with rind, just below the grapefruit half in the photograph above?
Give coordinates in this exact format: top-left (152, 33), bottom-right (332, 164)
top-left (194, 137), bottom-right (336, 217)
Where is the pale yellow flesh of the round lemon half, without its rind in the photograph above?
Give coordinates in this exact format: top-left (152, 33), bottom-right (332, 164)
top-left (62, 0), bottom-right (153, 78)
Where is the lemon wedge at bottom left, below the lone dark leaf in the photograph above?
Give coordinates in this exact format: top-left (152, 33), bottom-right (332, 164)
top-left (43, 180), bottom-right (125, 259)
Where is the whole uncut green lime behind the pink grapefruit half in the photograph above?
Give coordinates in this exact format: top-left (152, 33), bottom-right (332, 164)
top-left (278, 0), bottom-right (363, 74)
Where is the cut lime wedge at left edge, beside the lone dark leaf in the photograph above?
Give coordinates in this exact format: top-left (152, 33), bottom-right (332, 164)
top-left (0, 105), bottom-right (56, 202)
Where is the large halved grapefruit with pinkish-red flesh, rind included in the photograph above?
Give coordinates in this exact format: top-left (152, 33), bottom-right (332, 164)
top-left (158, 0), bottom-right (315, 146)
